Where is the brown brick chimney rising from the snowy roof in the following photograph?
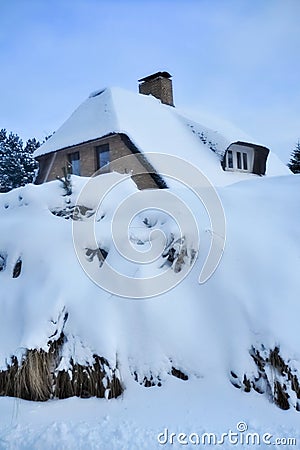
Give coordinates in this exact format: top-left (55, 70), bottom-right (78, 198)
top-left (139, 72), bottom-right (174, 106)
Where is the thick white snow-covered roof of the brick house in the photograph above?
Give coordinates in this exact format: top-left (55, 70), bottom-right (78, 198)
top-left (34, 88), bottom-right (290, 185)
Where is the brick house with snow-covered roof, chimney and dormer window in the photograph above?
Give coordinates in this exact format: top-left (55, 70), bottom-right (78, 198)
top-left (34, 72), bottom-right (289, 189)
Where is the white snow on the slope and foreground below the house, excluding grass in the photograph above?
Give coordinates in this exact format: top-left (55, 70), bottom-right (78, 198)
top-left (0, 174), bottom-right (300, 450)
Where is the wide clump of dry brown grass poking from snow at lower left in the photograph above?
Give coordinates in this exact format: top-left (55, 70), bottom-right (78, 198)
top-left (0, 335), bottom-right (123, 401)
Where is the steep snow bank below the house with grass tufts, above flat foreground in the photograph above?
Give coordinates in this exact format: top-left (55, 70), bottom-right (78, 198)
top-left (0, 173), bottom-right (300, 410)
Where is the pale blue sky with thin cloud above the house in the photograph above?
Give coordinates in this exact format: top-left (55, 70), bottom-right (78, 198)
top-left (0, 0), bottom-right (300, 162)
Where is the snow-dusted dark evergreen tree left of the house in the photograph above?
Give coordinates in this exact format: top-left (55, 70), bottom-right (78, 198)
top-left (0, 129), bottom-right (40, 192)
